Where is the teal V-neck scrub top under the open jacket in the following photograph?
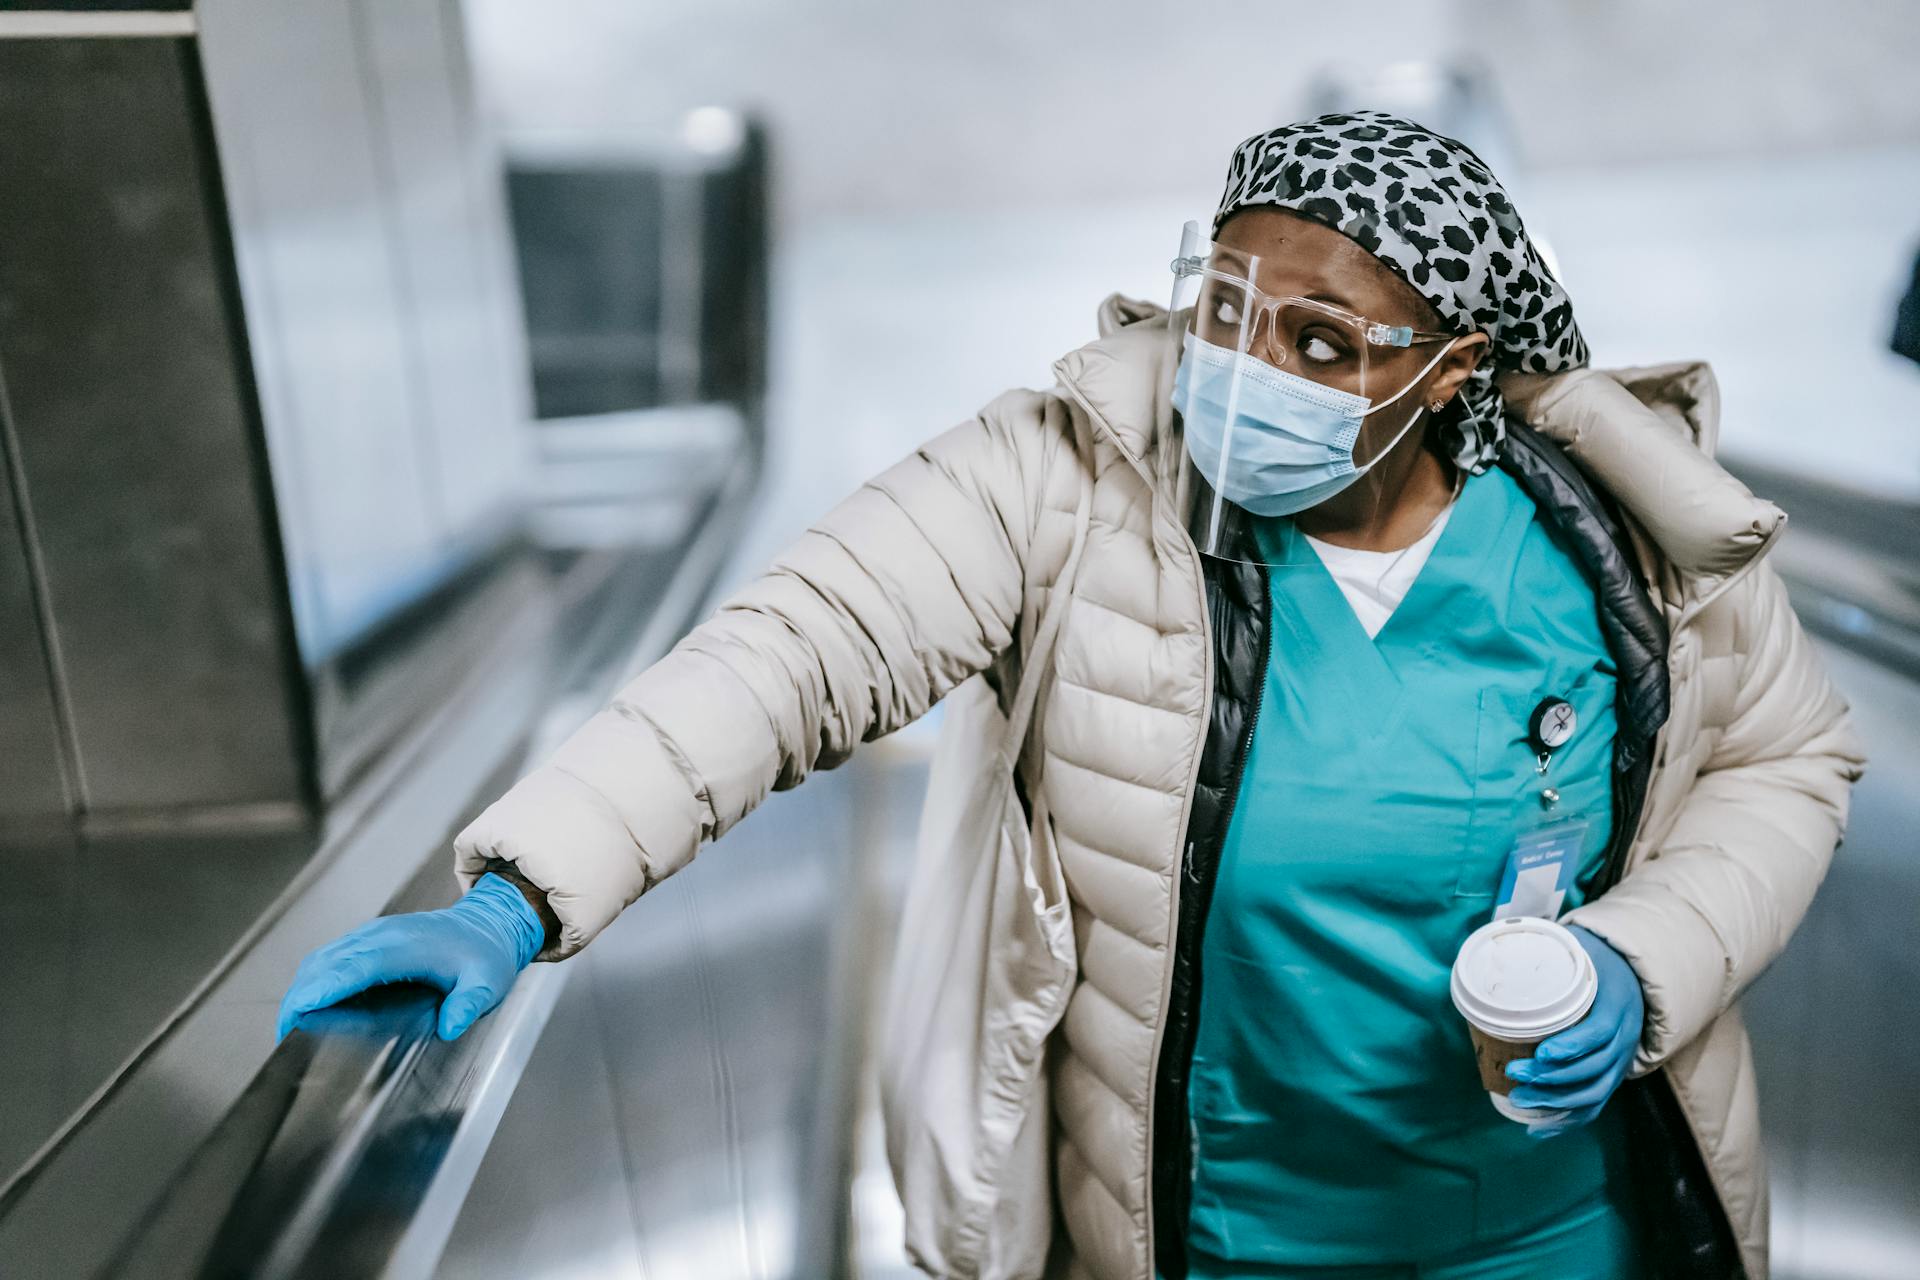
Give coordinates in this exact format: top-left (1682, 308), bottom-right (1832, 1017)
top-left (1188, 470), bottom-right (1619, 1276)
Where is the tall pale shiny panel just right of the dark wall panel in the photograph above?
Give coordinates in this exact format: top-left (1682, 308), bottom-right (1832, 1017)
top-left (198, 0), bottom-right (447, 664)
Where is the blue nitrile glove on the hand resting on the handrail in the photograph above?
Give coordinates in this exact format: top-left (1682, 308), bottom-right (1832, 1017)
top-left (280, 873), bottom-right (545, 1040)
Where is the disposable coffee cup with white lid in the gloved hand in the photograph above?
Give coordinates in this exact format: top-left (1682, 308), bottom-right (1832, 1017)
top-left (1452, 915), bottom-right (1599, 1123)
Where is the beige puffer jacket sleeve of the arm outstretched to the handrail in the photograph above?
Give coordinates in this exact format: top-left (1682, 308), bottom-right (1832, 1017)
top-left (455, 391), bottom-right (1079, 960)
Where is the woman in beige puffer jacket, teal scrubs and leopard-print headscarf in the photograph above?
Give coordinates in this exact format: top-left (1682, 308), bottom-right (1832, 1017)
top-left (282, 111), bottom-right (1862, 1280)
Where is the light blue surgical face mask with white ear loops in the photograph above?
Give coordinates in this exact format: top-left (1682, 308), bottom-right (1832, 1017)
top-left (1173, 334), bottom-right (1453, 516)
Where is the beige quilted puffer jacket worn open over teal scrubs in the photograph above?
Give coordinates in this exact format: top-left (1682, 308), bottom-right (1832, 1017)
top-left (457, 299), bottom-right (1862, 1280)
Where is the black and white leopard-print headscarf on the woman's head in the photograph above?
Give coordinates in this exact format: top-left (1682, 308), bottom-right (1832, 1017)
top-left (1213, 111), bottom-right (1586, 474)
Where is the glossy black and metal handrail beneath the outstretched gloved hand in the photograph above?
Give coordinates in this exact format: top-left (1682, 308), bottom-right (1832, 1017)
top-left (98, 455), bottom-right (755, 1278)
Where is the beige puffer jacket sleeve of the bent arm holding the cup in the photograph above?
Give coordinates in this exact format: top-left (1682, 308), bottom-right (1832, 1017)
top-left (1567, 564), bottom-right (1864, 1075)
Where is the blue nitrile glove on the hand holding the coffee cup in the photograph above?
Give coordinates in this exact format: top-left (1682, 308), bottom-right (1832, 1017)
top-left (1507, 925), bottom-right (1647, 1138)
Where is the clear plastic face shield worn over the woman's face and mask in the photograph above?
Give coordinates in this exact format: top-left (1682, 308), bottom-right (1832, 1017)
top-left (1167, 223), bottom-right (1455, 564)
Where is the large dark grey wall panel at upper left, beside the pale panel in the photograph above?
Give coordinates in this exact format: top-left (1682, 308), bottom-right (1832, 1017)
top-left (0, 38), bottom-right (303, 814)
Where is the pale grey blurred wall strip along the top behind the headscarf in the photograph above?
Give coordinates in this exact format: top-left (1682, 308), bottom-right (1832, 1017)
top-left (468, 0), bottom-right (1920, 223)
